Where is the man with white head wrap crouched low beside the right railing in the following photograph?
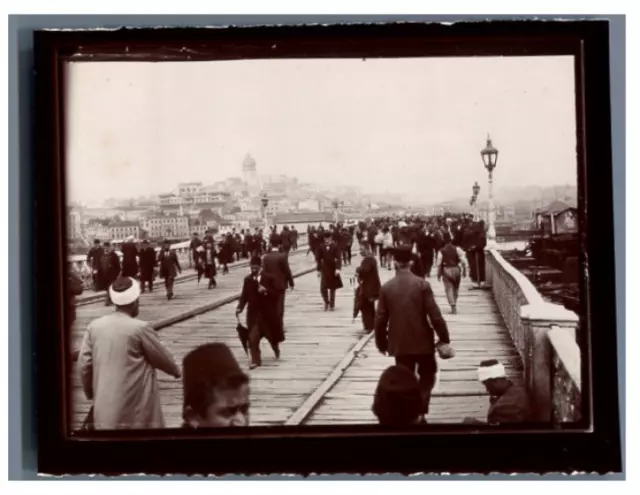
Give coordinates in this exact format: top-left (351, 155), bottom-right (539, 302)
top-left (464, 359), bottom-right (531, 425)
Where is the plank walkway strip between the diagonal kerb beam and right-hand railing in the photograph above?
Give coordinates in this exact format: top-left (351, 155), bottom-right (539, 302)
top-left (304, 278), bottom-right (522, 425)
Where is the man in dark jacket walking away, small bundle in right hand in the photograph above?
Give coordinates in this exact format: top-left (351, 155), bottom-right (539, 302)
top-left (375, 246), bottom-right (454, 412)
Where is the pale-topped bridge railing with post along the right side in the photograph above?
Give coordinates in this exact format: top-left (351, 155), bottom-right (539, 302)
top-left (486, 249), bottom-right (581, 423)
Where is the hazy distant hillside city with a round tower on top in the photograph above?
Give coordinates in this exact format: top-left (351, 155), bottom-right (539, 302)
top-left (67, 155), bottom-right (577, 251)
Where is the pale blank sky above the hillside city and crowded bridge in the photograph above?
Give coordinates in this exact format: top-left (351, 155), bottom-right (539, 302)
top-left (67, 57), bottom-right (577, 203)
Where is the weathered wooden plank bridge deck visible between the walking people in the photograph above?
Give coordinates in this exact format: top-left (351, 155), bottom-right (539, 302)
top-left (72, 255), bottom-right (521, 427)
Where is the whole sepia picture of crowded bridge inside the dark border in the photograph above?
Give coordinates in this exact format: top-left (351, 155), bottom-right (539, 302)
top-left (63, 51), bottom-right (589, 433)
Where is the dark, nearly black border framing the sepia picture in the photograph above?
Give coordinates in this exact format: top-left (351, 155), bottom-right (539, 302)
top-left (32, 21), bottom-right (621, 474)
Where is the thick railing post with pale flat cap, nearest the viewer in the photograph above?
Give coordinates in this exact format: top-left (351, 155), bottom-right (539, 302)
top-left (520, 302), bottom-right (579, 423)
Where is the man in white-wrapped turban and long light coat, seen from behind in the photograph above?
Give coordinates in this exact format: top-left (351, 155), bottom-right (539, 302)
top-left (78, 277), bottom-right (180, 430)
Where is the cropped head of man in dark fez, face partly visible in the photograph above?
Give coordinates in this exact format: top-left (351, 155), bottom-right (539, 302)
top-left (182, 343), bottom-right (250, 428)
